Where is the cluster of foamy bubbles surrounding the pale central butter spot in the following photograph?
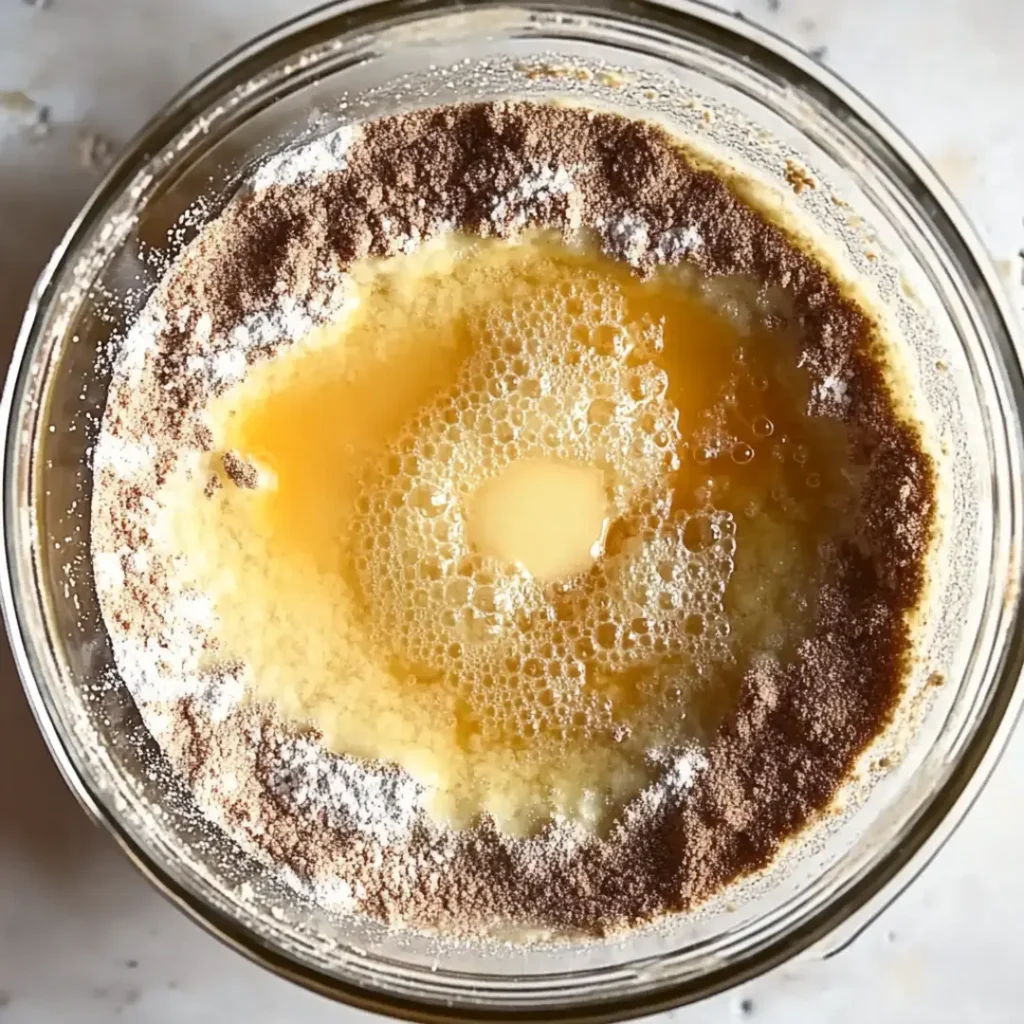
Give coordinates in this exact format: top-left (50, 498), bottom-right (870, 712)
top-left (355, 264), bottom-right (735, 737)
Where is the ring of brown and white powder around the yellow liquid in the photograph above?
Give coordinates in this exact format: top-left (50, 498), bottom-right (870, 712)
top-left (92, 102), bottom-right (934, 934)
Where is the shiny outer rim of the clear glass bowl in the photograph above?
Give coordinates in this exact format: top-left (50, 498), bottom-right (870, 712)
top-left (0, 0), bottom-right (1024, 1022)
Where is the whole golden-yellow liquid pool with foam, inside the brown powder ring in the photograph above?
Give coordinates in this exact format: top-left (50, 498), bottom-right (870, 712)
top-left (168, 234), bottom-right (854, 833)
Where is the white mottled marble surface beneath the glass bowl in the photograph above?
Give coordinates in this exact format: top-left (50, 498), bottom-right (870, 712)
top-left (0, 0), bottom-right (1024, 1024)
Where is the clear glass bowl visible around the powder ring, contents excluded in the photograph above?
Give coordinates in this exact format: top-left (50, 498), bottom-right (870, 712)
top-left (0, 0), bottom-right (1024, 1021)
